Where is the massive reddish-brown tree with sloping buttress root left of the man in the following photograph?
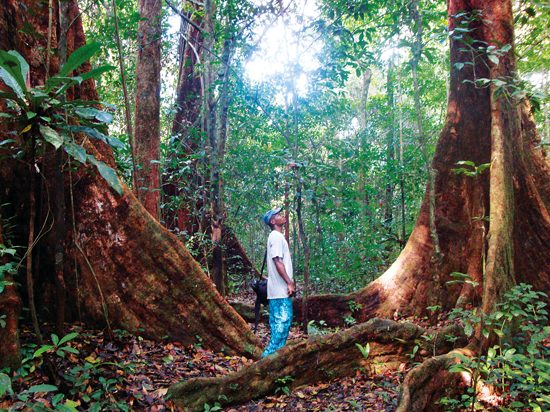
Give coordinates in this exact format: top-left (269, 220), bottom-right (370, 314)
top-left (0, 0), bottom-right (261, 361)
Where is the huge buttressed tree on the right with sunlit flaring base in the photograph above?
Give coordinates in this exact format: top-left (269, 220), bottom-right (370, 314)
top-left (296, 0), bottom-right (550, 323)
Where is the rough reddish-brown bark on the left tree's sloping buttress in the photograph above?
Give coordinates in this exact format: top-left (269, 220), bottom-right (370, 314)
top-left (0, 0), bottom-right (262, 358)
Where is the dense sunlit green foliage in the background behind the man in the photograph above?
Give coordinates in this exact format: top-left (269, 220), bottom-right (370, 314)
top-left (74, 0), bottom-right (550, 291)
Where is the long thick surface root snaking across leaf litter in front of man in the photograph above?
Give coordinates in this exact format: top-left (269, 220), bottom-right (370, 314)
top-left (169, 318), bottom-right (461, 410)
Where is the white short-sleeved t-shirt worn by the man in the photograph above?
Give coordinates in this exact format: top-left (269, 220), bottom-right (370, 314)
top-left (266, 230), bottom-right (293, 299)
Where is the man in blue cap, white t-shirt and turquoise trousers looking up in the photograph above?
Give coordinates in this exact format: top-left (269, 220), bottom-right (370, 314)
top-left (262, 207), bottom-right (296, 358)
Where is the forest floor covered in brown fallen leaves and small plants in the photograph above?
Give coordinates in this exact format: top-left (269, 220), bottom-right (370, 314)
top-left (0, 288), bottom-right (432, 412)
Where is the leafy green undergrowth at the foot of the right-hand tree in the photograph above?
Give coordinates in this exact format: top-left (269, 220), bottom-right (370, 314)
top-left (441, 284), bottom-right (550, 412)
